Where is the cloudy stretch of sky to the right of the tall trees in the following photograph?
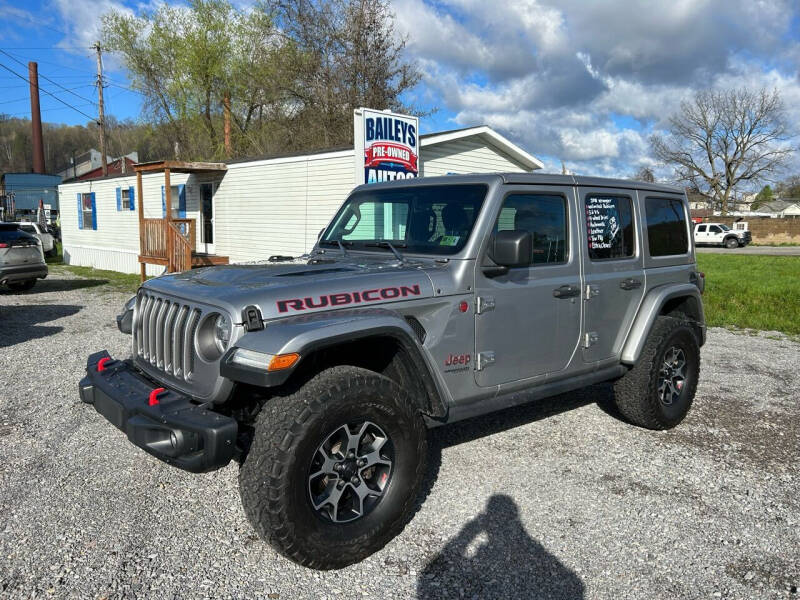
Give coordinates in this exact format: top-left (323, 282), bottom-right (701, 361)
top-left (394, 0), bottom-right (800, 176)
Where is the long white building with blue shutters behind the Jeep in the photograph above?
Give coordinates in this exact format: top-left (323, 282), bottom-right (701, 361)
top-left (59, 126), bottom-right (543, 275)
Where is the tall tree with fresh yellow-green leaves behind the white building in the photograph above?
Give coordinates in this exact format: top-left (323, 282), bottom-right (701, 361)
top-left (102, 0), bottom-right (282, 159)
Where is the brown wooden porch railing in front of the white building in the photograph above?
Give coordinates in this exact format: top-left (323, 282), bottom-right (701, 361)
top-left (140, 219), bottom-right (195, 273)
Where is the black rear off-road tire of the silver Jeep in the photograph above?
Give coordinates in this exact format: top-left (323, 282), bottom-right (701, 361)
top-left (614, 316), bottom-right (700, 430)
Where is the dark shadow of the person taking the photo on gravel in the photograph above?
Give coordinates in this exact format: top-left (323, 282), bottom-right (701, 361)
top-left (417, 494), bottom-right (585, 600)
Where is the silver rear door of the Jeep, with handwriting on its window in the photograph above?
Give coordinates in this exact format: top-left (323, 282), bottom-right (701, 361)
top-left (578, 188), bottom-right (645, 362)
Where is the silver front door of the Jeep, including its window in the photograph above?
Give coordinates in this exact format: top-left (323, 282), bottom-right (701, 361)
top-left (475, 186), bottom-right (581, 387)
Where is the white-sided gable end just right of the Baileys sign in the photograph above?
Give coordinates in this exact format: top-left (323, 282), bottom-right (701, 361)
top-left (420, 139), bottom-right (527, 177)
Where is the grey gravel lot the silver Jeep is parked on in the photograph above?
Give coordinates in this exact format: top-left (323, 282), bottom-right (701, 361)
top-left (0, 275), bottom-right (800, 599)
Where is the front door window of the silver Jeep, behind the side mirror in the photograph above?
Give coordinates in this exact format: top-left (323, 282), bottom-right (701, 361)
top-left (494, 194), bottom-right (567, 265)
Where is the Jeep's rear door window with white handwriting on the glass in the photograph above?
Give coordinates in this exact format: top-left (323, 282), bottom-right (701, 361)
top-left (586, 195), bottom-right (635, 260)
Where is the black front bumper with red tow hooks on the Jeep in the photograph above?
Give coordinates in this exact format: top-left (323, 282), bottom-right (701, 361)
top-left (78, 350), bottom-right (238, 473)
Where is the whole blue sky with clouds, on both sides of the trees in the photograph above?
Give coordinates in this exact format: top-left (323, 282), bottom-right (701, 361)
top-left (0, 0), bottom-right (800, 177)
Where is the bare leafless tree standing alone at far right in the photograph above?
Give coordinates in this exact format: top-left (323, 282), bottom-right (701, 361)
top-left (650, 89), bottom-right (794, 214)
